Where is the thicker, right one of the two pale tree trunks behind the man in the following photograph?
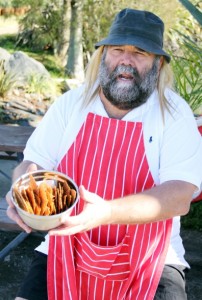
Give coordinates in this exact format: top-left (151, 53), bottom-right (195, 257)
top-left (65, 0), bottom-right (84, 80)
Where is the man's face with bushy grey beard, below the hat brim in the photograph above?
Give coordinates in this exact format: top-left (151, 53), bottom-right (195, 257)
top-left (99, 46), bottom-right (160, 110)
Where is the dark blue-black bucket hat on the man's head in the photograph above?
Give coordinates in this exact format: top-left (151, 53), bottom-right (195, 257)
top-left (95, 8), bottom-right (171, 62)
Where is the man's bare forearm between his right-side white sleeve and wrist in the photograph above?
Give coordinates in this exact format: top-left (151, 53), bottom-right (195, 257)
top-left (110, 181), bottom-right (196, 224)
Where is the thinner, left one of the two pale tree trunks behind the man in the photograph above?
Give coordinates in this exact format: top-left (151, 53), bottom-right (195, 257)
top-left (57, 0), bottom-right (71, 67)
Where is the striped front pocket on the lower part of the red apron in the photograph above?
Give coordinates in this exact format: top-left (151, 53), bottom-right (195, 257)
top-left (75, 233), bottom-right (130, 281)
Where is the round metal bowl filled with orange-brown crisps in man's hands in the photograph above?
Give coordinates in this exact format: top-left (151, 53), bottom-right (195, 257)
top-left (11, 170), bottom-right (79, 231)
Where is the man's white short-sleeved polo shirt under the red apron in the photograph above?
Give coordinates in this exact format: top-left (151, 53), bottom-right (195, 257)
top-left (24, 86), bottom-right (202, 266)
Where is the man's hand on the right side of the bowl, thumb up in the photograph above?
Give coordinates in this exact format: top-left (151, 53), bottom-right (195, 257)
top-left (49, 186), bottom-right (111, 235)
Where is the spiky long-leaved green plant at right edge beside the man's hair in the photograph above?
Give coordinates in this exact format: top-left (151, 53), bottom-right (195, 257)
top-left (170, 0), bottom-right (202, 113)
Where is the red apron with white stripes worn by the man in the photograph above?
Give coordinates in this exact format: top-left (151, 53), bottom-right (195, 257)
top-left (48, 113), bottom-right (172, 300)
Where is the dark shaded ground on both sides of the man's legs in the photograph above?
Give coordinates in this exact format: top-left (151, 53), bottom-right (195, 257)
top-left (0, 230), bottom-right (202, 300)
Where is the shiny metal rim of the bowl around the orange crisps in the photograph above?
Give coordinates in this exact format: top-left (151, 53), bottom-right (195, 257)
top-left (11, 169), bottom-right (79, 220)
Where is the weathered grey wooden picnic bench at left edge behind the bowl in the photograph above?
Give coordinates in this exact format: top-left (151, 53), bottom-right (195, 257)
top-left (0, 124), bottom-right (34, 260)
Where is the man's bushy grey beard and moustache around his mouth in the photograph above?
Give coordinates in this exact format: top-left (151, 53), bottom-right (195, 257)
top-left (98, 55), bottom-right (160, 110)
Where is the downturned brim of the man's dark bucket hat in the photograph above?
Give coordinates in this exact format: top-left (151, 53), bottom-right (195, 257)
top-left (95, 36), bottom-right (171, 63)
